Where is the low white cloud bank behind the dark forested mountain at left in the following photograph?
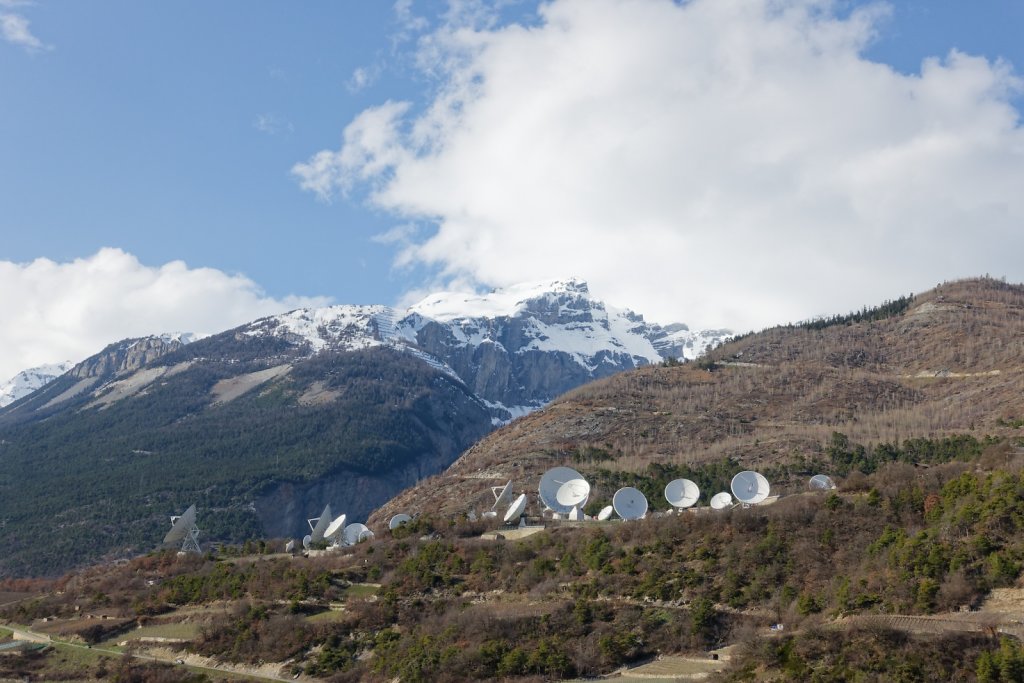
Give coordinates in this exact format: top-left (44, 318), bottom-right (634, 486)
top-left (0, 249), bottom-right (329, 381)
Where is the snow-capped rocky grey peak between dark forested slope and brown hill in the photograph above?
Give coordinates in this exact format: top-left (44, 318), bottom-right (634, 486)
top-left (240, 279), bottom-right (730, 423)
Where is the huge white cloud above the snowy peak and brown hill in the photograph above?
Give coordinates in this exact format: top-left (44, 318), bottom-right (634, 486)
top-left (293, 0), bottom-right (1024, 329)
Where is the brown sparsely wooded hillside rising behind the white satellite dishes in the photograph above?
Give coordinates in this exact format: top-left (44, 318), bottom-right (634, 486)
top-left (374, 279), bottom-right (1024, 520)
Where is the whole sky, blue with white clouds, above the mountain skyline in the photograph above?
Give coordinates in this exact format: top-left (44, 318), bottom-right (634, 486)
top-left (0, 0), bottom-right (1024, 379)
